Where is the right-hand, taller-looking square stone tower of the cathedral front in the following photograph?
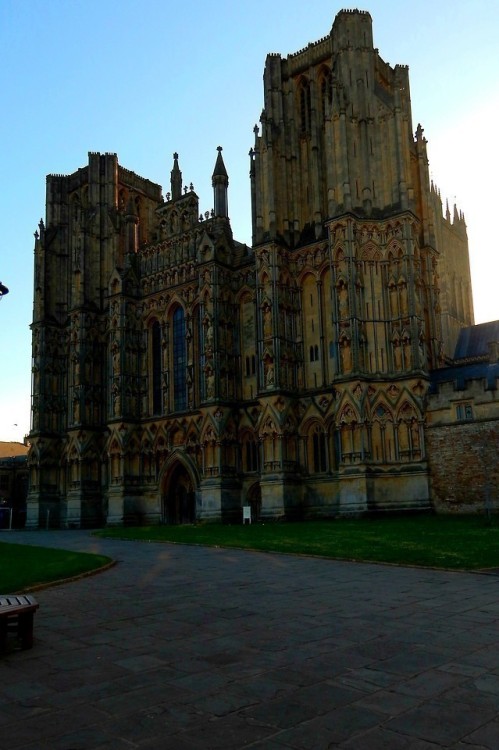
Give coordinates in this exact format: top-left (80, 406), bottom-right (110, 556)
top-left (250, 11), bottom-right (473, 512)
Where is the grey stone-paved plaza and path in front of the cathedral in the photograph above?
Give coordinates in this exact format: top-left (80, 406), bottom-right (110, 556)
top-left (0, 531), bottom-right (499, 750)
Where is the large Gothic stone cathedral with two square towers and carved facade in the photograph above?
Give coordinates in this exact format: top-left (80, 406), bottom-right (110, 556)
top-left (27, 10), bottom-right (473, 528)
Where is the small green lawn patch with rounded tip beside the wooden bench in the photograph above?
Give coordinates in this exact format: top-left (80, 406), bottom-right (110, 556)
top-left (0, 542), bottom-right (110, 594)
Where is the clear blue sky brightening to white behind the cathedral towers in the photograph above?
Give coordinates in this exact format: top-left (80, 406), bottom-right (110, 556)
top-left (0, 0), bottom-right (499, 440)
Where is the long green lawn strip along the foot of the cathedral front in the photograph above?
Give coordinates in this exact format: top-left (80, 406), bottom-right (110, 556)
top-left (96, 515), bottom-right (499, 570)
